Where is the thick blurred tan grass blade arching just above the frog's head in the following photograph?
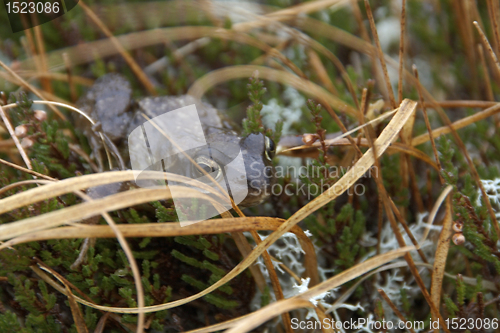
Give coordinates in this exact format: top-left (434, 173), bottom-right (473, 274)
top-left (188, 65), bottom-right (357, 115)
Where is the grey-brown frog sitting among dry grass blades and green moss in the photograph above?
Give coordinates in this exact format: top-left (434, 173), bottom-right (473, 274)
top-left (76, 73), bottom-right (276, 208)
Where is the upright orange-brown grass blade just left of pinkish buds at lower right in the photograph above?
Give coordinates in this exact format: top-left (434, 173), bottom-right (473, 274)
top-left (431, 196), bottom-right (453, 320)
